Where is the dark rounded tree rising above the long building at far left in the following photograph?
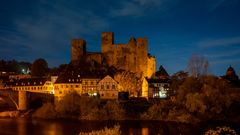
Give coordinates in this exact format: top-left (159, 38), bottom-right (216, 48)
top-left (31, 58), bottom-right (48, 77)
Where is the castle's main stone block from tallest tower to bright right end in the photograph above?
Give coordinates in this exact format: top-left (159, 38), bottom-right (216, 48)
top-left (102, 32), bottom-right (155, 77)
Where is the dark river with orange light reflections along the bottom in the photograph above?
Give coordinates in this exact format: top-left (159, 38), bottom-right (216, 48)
top-left (0, 118), bottom-right (239, 135)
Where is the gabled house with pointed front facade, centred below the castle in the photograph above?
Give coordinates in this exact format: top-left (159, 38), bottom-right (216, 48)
top-left (97, 75), bottom-right (118, 99)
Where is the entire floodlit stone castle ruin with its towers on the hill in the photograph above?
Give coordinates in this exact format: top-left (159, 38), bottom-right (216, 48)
top-left (71, 32), bottom-right (156, 78)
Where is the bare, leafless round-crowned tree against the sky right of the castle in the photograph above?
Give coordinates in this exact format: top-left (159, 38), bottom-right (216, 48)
top-left (187, 55), bottom-right (209, 77)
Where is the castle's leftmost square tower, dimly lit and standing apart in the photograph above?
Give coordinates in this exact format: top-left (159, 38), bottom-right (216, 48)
top-left (71, 39), bottom-right (86, 62)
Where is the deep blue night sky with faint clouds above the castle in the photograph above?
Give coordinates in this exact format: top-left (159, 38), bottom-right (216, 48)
top-left (0, 0), bottom-right (240, 75)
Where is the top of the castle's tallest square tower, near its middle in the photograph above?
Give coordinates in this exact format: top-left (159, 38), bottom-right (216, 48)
top-left (101, 32), bottom-right (114, 53)
